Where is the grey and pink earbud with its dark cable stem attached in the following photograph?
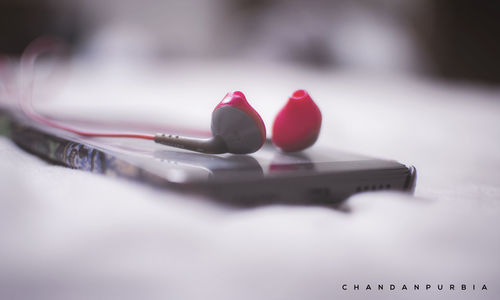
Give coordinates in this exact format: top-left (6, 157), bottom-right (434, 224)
top-left (154, 91), bottom-right (266, 154)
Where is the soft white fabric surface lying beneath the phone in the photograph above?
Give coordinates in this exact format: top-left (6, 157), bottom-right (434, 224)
top-left (0, 62), bottom-right (500, 299)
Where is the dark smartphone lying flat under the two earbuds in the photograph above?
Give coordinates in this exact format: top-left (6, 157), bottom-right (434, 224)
top-left (0, 112), bottom-right (416, 207)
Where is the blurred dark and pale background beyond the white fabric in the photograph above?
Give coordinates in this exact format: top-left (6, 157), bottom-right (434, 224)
top-left (0, 0), bottom-right (500, 84)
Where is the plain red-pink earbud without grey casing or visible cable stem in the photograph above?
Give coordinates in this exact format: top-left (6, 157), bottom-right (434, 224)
top-left (272, 90), bottom-right (322, 152)
